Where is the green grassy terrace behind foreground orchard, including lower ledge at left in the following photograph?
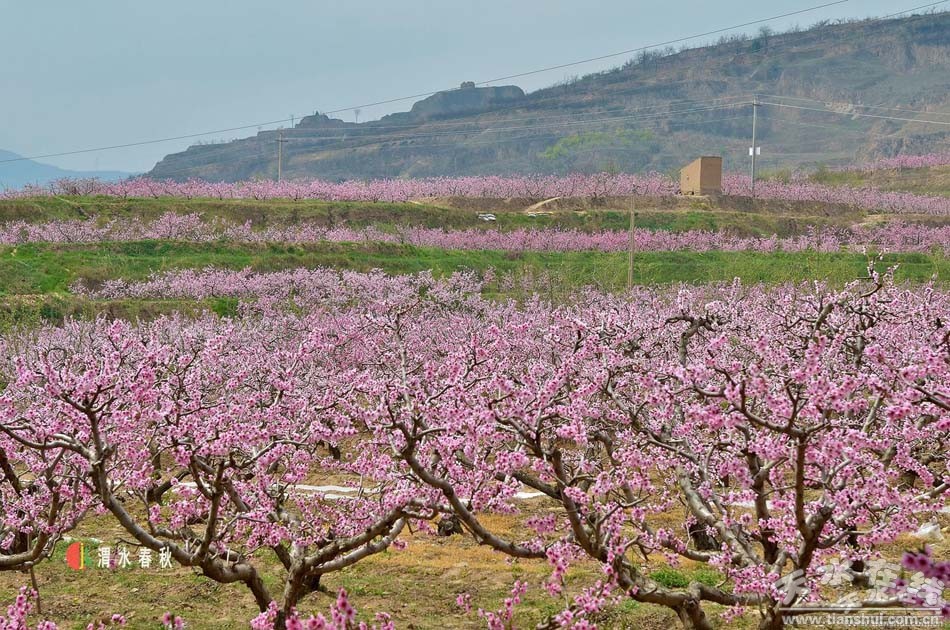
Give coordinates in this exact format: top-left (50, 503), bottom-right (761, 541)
top-left (0, 241), bottom-right (950, 333)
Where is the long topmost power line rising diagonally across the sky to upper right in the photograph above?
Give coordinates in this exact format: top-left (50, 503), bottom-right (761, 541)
top-left (0, 0), bottom-right (880, 164)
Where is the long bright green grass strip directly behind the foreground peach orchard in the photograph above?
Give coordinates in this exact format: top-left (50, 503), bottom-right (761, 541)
top-left (0, 241), bottom-right (950, 308)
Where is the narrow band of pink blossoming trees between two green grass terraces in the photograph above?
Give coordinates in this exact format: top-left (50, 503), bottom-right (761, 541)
top-left (0, 212), bottom-right (950, 252)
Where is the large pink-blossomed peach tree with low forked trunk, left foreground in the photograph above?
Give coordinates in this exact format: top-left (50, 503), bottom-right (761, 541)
top-left (0, 317), bottom-right (442, 627)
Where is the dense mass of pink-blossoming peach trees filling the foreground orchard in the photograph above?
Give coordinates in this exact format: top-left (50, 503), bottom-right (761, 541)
top-left (0, 274), bottom-right (950, 628)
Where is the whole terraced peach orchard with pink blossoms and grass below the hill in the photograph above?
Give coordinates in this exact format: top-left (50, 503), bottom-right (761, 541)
top-left (0, 166), bottom-right (950, 630)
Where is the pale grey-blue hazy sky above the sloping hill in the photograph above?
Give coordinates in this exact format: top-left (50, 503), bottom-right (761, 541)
top-left (0, 0), bottom-right (926, 170)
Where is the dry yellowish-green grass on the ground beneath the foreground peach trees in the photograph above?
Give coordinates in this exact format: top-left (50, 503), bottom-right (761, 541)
top-left (0, 512), bottom-right (947, 630)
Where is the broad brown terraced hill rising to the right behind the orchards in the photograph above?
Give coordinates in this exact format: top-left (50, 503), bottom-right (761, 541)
top-left (150, 12), bottom-right (950, 181)
